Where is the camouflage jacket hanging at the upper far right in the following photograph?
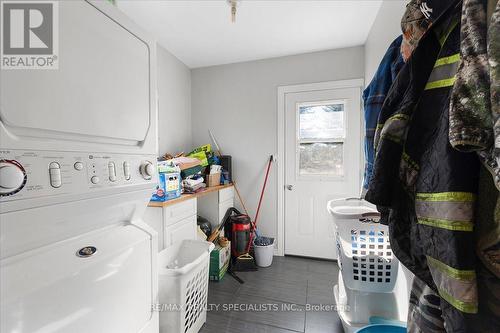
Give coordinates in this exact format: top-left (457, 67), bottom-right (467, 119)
top-left (450, 0), bottom-right (500, 190)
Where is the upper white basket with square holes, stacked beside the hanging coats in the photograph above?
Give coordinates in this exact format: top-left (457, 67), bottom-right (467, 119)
top-left (328, 198), bottom-right (399, 293)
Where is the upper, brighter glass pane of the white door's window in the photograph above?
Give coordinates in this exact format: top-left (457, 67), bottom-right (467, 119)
top-left (299, 101), bottom-right (345, 140)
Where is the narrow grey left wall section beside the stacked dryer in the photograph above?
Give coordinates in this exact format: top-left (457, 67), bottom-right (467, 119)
top-left (157, 45), bottom-right (192, 155)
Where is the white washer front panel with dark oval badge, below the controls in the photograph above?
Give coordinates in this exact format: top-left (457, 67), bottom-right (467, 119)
top-left (0, 225), bottom-right (157, 333)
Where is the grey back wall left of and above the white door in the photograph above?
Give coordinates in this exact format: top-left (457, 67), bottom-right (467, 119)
top-left (191, 46), bottom-right (365, 244)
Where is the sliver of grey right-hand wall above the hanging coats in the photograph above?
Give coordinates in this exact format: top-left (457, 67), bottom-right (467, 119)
top-left (365, 0), bottom-right (408, 85)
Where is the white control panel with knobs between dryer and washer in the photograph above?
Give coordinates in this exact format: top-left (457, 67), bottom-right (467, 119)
top-left (0, 150), bottom-right (157, 201)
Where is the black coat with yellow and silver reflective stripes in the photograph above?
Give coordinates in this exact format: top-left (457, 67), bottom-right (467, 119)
top-left (366, 1), bottom-right (494, 332)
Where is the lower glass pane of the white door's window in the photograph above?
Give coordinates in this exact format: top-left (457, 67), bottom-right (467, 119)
top-left (299, 142), bottom-right (344, 176)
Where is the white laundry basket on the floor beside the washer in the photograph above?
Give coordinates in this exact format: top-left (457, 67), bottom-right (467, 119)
top-left (158, 240), bottom-right (214, 333)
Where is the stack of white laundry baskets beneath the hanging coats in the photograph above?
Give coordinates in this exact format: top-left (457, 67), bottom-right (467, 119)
top-left (327, 198), bottom-right (408, 333)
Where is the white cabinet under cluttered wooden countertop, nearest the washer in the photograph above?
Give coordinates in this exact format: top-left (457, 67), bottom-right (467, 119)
top-left (143, 198), bottom-right (197, 251)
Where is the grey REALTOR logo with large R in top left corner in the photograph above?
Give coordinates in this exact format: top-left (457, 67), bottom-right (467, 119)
top-left (0, 1), bottom-right (59, 69)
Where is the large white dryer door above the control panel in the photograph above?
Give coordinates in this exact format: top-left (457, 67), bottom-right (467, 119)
top-left (0, 1), bottom-right (156, 148)
